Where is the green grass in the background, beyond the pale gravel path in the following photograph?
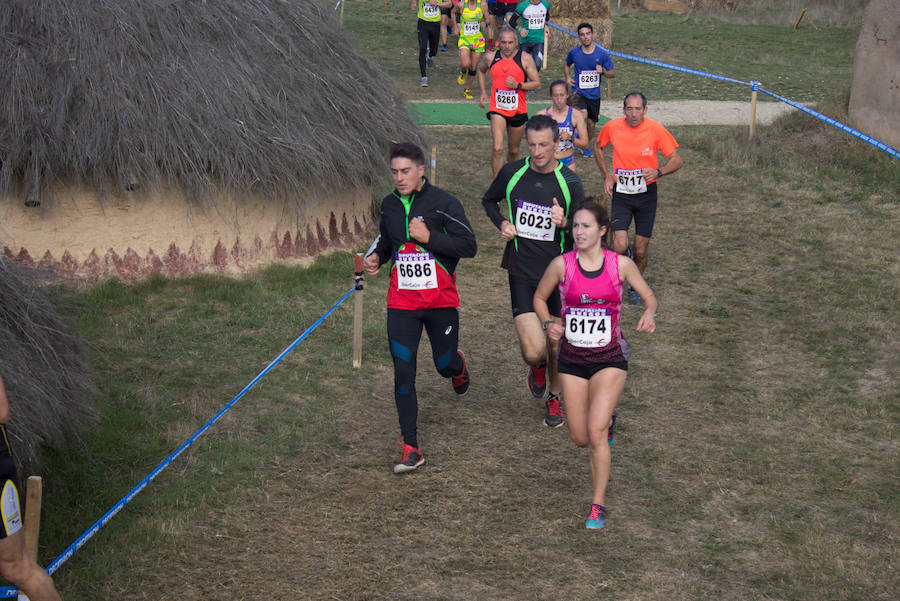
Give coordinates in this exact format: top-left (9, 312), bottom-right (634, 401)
top-left (344, 0), bottom-right (862, 102)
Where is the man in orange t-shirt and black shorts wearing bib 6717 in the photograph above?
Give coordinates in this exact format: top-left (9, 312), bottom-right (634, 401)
top-left (594, 92), bottom-right (684, 305)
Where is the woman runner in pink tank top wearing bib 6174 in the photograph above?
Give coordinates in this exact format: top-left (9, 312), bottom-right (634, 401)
top-left (534, 197), bottom-right (658, 530)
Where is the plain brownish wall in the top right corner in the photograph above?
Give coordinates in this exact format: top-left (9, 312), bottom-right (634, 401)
top-left (849, 0), bottom-right (900, 148)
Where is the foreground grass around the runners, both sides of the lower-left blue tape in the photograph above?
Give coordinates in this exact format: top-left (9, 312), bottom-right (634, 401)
top-left (17, 1), bottom-right (900, 601)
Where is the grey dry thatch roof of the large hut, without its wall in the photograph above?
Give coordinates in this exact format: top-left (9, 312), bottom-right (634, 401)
top-left (0, 0), bottom-right (422, 204)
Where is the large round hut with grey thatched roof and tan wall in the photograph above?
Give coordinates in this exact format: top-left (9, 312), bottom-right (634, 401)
top-left (0, 0), bottom-right (422, 278)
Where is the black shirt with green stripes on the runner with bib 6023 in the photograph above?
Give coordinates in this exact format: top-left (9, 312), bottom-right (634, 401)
top-left (481, 159), bottom-right (584, 282)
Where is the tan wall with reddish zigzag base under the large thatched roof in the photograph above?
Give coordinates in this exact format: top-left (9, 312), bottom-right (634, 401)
top-left (0, 185), bottom-right (374, 281)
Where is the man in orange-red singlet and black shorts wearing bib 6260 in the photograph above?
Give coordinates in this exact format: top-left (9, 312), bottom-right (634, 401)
top-left (478, 28), bottom-right (541, 177)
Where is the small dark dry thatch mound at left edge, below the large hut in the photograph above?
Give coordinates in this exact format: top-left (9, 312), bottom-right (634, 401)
top-left (0, 257), bottom-right (97, 474)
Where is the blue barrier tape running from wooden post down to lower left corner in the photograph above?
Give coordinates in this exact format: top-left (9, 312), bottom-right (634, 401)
top-left (0, 288), bottom-right (355, 598)
